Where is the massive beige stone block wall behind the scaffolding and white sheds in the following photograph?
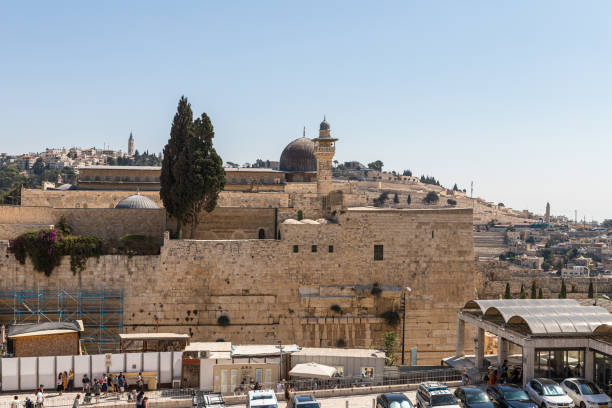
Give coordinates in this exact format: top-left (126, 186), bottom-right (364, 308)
top-left (0, 209), bottom-right (476, 364)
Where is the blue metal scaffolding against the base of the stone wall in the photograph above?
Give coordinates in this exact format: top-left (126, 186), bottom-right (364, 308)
top-left (0, 288), bottom-right (123, 354)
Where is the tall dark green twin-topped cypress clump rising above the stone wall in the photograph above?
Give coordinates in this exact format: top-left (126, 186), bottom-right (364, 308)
top-left (160, 96), bottom-right (225, 238)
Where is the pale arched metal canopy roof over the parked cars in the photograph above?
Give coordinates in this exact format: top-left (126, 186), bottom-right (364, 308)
top-left (463, 299), bottom-right (612, 336)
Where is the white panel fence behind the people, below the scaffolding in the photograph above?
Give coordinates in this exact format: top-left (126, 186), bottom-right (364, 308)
top-left (0, 351), bottom-right (183, 391)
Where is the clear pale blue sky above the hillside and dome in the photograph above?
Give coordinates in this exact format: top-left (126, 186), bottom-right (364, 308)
top-left (0, 0), bottom-right (612, 221)
